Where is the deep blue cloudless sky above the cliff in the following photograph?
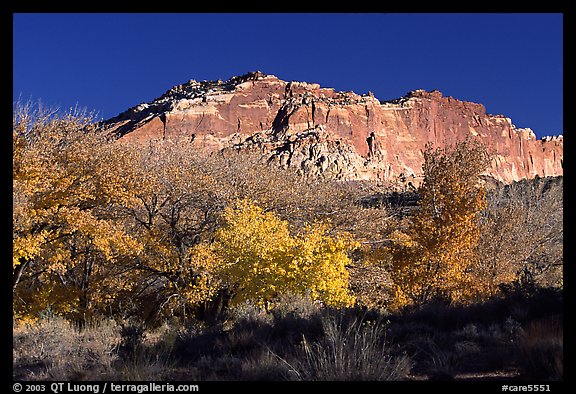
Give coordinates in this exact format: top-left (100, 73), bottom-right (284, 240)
top-left (13, 13), bottom-right (563, 137)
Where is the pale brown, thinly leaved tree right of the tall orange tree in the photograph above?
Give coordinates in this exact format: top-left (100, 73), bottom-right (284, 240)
top-left (476, 177), bottom-right (564, 289)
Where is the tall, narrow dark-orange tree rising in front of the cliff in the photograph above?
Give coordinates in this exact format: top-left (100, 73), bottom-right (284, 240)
top-left (391, 140), bottom-right (489, 306)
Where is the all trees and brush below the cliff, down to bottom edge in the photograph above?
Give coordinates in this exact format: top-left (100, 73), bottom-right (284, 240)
top-left (13, 106), bottom-right (563, 380)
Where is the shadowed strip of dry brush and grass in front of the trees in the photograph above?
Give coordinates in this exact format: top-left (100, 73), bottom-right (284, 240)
top-left (14, 289), bottom-right (563, 382)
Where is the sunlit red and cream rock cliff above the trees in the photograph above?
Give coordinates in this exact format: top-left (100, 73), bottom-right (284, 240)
top-left (105, 72), bottom-right (563, 183)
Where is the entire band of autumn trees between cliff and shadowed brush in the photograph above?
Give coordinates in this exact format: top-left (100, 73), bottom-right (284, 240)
top-left (13, 106), bottom-right (562, 321)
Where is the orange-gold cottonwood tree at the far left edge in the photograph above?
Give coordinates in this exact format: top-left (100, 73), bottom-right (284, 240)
top-left (12, 103), bottom-right (140, 319)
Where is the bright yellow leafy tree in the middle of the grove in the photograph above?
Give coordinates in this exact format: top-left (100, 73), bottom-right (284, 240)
top-left (214, 199), bottom-right (355, 307)
